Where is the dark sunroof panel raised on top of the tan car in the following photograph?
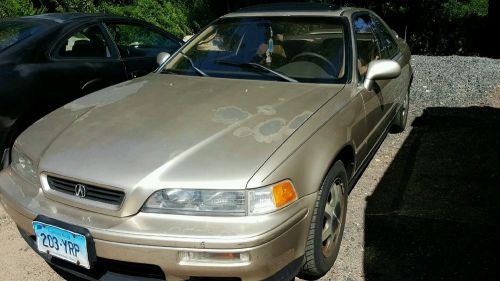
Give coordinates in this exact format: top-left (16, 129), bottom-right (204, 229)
top-left (238, 3), bottom-right (340, 13)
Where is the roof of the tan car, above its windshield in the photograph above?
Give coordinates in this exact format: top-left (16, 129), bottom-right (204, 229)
top-left (223, 3), bottom-right (368, 18)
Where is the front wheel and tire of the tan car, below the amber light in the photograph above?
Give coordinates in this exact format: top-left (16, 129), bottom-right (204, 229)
top-left (298, 161), bottom-right (348, 280)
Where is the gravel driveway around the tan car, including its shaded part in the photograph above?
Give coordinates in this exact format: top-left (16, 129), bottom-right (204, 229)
top-left (0, 56), bottom-right (500, 281)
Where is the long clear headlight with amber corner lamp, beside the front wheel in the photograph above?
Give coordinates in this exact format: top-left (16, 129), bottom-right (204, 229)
top-left (142, 180), bottom-right (297, 216)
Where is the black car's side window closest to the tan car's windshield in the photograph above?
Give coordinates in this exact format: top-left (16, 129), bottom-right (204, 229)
top-left (107, 23), bottom-right (179, 58)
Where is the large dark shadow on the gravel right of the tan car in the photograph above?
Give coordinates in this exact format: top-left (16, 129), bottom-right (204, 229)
top-left (364, 107), bottom-right (500, 280)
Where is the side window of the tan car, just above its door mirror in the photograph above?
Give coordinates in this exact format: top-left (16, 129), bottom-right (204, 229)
top-left (353, 14), bottom-right (380, 80)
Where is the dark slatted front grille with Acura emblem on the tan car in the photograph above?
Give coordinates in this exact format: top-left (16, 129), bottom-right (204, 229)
top-left (47, 176), bottom-right (125, 206)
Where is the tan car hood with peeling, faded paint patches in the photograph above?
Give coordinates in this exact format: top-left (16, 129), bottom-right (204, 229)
top-left (39, 74), bottom-right (343, 193)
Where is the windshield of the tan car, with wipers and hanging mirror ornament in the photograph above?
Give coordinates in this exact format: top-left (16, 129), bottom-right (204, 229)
top-left (162, 17), bottom-right (347, 83)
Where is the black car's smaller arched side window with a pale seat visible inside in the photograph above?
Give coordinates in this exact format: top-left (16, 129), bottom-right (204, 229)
top-left (56, 25), bottom-right (111, 58)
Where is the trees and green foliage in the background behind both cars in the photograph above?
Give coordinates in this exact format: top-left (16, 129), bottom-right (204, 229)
top-left (0, 0), bottom-right (494, 54)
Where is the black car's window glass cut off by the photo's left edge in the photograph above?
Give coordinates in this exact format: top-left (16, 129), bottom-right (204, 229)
top-left (0, 21), bottom-right (43, 52)
